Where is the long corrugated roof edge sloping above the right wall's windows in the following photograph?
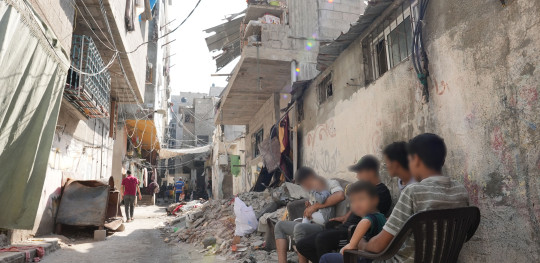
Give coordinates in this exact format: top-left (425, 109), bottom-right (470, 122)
top-left (317, 0), bottom-right (394, 71)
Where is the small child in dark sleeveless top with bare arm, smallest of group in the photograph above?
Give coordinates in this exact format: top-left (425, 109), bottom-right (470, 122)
top-left (320, 181), bottom-right (386, 263)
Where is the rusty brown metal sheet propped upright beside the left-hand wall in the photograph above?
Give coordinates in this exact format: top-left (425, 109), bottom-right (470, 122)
top-left (56, 181), bottom-right (110, 226)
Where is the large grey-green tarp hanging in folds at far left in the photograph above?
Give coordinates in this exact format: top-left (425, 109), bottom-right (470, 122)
top-left (0, 0), bottom-right (69, 229)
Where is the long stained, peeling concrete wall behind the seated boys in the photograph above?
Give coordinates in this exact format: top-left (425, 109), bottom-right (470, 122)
top-left (299, 1), bottom-right (540, 262)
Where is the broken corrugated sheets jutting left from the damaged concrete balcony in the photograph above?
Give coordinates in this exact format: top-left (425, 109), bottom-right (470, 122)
top-left (204, 17), bottom-right (243, 71)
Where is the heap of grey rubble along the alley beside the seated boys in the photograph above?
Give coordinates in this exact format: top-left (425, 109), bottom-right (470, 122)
top-left (160, 184), bottom-right (306, 262)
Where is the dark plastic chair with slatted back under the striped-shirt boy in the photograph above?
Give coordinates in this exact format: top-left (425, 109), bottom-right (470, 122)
top-left (344, 206), bottom-right (480, 263)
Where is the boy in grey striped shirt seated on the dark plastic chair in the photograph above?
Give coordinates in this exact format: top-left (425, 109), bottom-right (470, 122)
top-left (359, 133), bottom-right (469, 262)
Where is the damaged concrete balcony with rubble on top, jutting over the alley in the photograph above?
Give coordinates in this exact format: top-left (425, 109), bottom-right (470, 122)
top-left (216, 4), bottom-right (299, 125)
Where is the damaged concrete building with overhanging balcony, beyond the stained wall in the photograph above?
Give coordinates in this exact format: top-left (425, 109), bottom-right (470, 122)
top-left (212, 0), bottom-right (364, 194)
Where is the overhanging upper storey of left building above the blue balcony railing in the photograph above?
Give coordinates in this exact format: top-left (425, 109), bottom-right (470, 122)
top-left (74, 0), bottom-right (151, 103)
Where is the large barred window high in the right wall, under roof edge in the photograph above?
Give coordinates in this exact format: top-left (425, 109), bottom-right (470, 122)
top-left (363, 2), bottom-right (416, 82)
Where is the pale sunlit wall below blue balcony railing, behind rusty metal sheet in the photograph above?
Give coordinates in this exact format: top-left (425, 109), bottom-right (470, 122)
top-left (33, 100), bottom-right (114, 235)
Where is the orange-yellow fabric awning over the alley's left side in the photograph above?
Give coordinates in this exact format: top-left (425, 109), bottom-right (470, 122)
top-left (126, 120), bottom-right (160, 151)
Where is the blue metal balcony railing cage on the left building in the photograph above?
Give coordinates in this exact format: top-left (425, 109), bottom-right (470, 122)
top-left (64, 35), bottom-right (111, 118)
